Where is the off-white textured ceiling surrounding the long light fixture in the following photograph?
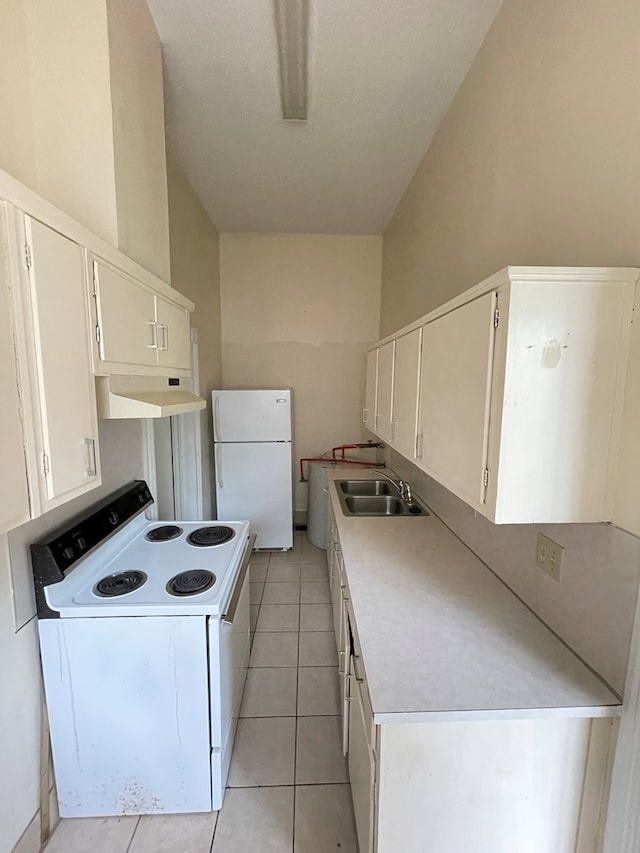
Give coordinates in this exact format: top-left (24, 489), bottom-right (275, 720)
top-left (149, 0), bottom-right (502, 234)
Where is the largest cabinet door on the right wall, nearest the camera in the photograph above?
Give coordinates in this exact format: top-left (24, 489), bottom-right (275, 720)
top-left (417, 293), bottom-right (496, 508)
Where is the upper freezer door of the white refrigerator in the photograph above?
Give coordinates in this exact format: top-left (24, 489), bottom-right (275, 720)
top-left (212, 388), bottom-right (291, 441)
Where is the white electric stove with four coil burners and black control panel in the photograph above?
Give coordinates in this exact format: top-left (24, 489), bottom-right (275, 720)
top-left (31, 481), bottom-right (254, 817)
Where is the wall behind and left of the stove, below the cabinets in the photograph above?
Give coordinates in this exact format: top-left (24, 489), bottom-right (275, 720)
top-left (0, 420), bottom-right (144, 853)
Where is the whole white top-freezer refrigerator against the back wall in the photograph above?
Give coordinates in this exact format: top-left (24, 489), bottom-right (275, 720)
top-left (212, 389), bottom-right (293, 550)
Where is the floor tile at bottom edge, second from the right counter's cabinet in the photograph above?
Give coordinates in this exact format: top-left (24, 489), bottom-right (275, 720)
top-left (215, 788), bottom-right (296, 853)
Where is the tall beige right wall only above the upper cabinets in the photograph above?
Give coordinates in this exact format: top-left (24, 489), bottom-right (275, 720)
top-left (381, 0), bottom-right (640, 335)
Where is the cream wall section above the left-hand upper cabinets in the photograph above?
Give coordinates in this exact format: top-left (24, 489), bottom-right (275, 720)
top-left (0, 0), bottom-right (169, 280)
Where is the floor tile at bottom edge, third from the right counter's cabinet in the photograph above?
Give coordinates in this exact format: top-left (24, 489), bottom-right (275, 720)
top-left (127, 812), bottom-right (218, 853)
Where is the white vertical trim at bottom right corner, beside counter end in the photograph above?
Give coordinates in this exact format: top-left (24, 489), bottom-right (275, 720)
top-left (603, 584), bottom-right (640, 853)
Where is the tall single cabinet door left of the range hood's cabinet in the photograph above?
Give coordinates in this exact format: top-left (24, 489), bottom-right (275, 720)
top-left (25, 216), bottom-right (100, 511)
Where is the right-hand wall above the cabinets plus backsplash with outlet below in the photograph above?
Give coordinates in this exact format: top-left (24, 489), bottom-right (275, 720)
top-left (381, 0), bottom-right (640, 691)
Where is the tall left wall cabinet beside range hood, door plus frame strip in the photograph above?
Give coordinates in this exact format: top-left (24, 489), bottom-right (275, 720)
top-left (15, 211), bottom-right (101, 514)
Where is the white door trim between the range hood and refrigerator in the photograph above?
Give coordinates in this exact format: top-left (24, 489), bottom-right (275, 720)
top-left (171, 329), bottom-right (204, 521)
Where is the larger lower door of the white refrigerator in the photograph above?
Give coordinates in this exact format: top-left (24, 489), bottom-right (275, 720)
top-left (215, 442), bottom-right (293, 548)
